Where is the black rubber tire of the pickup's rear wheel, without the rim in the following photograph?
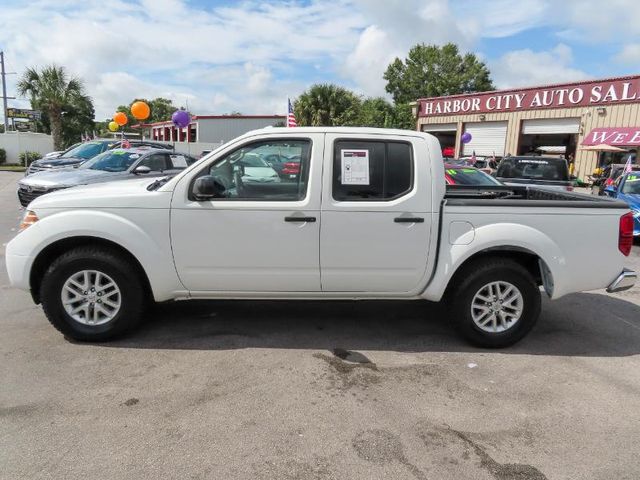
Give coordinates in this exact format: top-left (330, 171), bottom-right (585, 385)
top-left (446, 258), bottom-right (540, 348)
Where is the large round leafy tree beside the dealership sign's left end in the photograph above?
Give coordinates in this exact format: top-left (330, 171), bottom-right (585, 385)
top-left (384, 43), bottom-right (494, 104)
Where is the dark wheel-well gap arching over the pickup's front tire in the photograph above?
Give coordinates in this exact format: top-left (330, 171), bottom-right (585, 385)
top-left (29, 235), bottom-right (153, 304)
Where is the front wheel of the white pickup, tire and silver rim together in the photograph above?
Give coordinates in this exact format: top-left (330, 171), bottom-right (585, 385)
top-left (40, 247), bottom-right (145, 342)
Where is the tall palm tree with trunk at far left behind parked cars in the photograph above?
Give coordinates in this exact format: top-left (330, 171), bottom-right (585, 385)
top-left (18, 65), bottom-right (84, 150)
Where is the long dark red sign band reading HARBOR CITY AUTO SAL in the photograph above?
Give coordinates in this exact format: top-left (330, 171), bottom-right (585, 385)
top-left (419, 76), bottom-right (640, 117)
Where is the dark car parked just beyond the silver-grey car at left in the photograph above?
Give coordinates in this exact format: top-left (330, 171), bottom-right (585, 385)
top-left (25, 138), bottom-right (173, 176)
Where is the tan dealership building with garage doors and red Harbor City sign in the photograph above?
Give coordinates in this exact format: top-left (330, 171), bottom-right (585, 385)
top-left (417, 75), bottom-right (640, 178)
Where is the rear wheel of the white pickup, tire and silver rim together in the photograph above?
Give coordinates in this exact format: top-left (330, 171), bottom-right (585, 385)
top-left (448, 259), bottom-right (540, 348)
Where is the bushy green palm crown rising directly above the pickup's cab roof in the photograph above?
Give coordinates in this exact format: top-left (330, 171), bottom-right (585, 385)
top-left (293, 84), bottom-right (361, 127)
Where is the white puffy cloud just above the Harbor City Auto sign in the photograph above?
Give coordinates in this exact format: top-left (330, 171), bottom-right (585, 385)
top-left (489, 44), bottom-right (589, 88)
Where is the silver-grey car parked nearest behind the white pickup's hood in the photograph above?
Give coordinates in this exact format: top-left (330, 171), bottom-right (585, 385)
top-left (18, 147), bottom-right (196, 207)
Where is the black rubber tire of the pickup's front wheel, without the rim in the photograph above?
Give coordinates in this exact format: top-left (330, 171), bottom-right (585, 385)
top-left (40, 247), bottom-right (147, 342)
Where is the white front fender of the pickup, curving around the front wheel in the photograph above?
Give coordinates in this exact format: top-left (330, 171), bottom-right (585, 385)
top-left (6, 209), bottom-right (184, 301)
